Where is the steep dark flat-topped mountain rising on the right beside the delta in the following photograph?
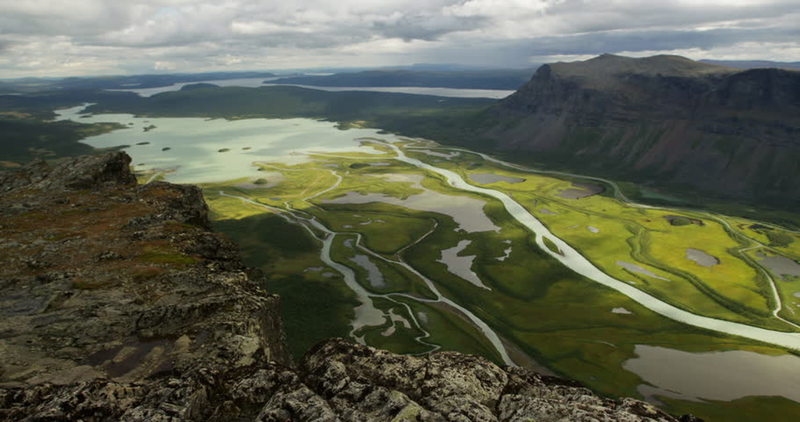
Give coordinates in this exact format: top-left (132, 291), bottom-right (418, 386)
top-left (479, 55), bottom-right (800, 207)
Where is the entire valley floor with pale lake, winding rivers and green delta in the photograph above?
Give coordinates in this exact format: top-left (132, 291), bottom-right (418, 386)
top-left (54, 107), bottom-right (800, 420)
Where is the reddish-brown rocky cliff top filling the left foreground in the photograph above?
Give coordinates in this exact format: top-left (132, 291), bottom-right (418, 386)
top-left (0, 153), bottom-right (291, 420)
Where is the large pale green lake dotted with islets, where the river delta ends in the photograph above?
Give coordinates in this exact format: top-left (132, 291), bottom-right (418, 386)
top-left (57, 106), bottom-right (394, 183)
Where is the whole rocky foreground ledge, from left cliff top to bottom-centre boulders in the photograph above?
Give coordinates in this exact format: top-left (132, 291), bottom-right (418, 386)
top-left (0, 153), bottom-right (693, 421)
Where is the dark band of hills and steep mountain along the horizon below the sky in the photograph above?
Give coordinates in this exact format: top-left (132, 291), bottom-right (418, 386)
top-left (0, 55), bottom-right (800, 210)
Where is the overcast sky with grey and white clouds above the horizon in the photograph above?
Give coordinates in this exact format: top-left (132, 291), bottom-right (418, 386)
top-left (0, 0), bottom-right (800, 78)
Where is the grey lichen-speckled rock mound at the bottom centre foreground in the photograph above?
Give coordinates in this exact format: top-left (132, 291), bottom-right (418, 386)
top-left (301, 340), bottom-right (690, 422)
